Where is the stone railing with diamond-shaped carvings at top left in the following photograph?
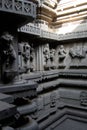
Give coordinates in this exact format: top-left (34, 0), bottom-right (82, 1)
top-left (0, 0), bottom-right (36, 18)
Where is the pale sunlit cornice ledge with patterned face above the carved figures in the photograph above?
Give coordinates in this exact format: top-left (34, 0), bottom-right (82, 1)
top-left (18, 25), bottom-right (87, 41)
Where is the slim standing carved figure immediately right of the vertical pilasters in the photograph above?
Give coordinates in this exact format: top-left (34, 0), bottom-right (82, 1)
top-left (43, 43), bottom-right (50, 66)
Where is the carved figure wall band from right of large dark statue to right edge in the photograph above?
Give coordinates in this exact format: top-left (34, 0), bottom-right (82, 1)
top-left (18, 41), bottom-right (87, 72)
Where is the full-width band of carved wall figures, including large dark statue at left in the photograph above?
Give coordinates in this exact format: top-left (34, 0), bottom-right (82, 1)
top-left (0, 32), bottom-right (87, 83)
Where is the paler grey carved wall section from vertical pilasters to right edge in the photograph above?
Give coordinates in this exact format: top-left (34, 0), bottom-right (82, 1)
top-left (33, 41), bottom-right (87, 70)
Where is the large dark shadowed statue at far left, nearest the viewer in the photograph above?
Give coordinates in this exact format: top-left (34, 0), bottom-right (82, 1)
top-left (0, 32), bottom-right (17, 82)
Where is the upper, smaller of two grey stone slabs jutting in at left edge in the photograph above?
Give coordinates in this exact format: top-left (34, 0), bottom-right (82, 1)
top-left (0, 93), bottom-right (14, 103)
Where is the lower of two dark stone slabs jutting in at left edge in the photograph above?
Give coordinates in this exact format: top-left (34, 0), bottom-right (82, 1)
top-left (0, 101), bottom-right (17, 120)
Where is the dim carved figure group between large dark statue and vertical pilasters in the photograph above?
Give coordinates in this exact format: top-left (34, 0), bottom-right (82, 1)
top-left (19, 42), bottom-right (34, 73)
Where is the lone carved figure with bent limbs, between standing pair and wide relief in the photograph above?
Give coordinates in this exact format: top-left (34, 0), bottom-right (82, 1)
top-left (58, 45), bottom-right (67, 61)
